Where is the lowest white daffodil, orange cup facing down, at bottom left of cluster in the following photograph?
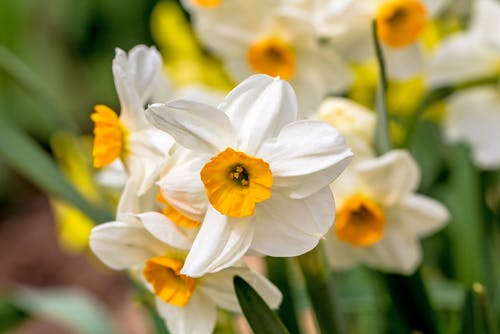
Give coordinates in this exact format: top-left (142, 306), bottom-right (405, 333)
top-left (90, 212), bottom-right (281, 334)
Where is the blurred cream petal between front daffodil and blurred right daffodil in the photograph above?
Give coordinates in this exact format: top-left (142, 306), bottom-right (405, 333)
top-left (356, 150), bottom-right (420, 206)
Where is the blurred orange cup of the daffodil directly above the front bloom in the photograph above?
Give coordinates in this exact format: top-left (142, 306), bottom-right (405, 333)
top-left (247, 37), bottom-right (295, 80)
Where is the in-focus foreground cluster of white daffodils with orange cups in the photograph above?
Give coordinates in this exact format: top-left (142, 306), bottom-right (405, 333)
top-left (90, 46), bottom-right (352, 333)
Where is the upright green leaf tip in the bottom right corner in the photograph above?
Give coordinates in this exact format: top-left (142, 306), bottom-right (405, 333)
top-left (461, 283), bottom-right (498, 334)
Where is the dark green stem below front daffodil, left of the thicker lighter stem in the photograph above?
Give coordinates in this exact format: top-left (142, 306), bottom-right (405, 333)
top-left (266, 256), bottom-right (300, 334)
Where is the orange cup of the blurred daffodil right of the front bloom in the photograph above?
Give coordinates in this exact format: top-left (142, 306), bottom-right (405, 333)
top-left (335, 196), bottom-right (386, 246)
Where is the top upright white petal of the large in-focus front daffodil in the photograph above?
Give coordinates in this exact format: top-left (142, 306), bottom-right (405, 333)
top-left (219, 74), bottom-right (297, 155)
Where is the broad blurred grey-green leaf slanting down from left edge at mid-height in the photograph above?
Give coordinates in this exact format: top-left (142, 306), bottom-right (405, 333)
top-left (0, 111), bottom-right (113, 222)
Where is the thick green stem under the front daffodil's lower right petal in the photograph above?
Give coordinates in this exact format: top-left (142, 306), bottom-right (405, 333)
top-left (297, 245), bottom-right (347, 334)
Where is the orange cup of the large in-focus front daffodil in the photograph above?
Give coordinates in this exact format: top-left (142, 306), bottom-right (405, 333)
top-left (200, 148), bottom-right (273, 217)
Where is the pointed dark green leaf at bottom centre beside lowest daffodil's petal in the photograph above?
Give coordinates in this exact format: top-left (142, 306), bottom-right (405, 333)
top-left (233, 276), bottom-right (289, 334)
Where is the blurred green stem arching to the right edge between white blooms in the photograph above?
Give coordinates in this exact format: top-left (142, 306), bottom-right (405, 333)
top-left (403, 75), bottom-right (500, 147)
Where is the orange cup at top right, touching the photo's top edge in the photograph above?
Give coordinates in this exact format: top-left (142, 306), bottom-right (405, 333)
top-left (376, 0), bottom-right (427, 48)
